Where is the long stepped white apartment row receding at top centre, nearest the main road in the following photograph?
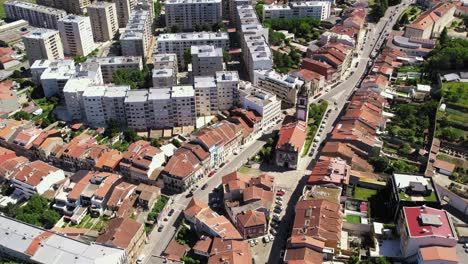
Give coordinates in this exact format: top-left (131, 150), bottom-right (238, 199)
top-left (236, 5), bottom-right (273, 80)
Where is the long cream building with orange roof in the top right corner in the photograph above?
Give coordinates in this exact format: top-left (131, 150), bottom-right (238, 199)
top-left (405, 2), bottom-right (456, 39)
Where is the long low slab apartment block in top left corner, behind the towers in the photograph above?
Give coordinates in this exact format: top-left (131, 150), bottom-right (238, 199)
top-left (3, 0), bottom-right (67, 29)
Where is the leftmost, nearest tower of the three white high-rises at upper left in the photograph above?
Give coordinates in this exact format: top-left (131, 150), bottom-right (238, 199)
top-left (23, 28), bottom-right (63, 65)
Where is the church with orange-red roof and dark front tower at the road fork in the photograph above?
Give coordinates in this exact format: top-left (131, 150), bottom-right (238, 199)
top-left (275, 120), bottom-right (307, 169)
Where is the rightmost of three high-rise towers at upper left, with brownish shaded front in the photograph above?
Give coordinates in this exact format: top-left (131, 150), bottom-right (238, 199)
top-left (88, 1), bottom-right (119, 42)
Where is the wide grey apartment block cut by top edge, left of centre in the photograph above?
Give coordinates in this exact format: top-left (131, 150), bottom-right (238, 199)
top-left (165, 0), bottom-right (222, 30)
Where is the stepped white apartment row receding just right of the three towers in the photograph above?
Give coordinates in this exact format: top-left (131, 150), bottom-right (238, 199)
top-left (120, 9), bottom-right (153, 57)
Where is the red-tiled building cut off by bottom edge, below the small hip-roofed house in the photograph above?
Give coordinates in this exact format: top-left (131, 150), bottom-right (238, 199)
top-left (208, 237), bottom-right (252, 264)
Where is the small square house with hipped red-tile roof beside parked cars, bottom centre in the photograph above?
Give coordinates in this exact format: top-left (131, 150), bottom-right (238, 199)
top-left (236, 210), bottom-right (267, 239)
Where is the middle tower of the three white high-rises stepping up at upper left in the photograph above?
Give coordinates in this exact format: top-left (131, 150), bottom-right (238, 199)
top-left (58, 15), bottom-right (95, 56)
